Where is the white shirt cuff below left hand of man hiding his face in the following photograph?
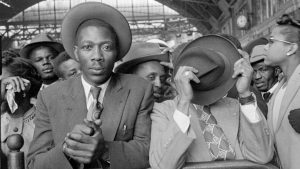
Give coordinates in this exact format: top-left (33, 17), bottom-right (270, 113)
top-left (173, 110), bottom-right (191, 133)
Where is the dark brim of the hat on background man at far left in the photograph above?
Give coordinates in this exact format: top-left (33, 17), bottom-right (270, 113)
top-left (20, 41), bottom-right (64, 59)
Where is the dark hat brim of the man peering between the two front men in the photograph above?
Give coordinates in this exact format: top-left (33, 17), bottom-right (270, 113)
top-left (115, 53), bottom-right (169, 73)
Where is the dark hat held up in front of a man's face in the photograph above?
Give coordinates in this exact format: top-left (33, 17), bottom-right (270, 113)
top-left (174, 35), bottom-right (241, 105)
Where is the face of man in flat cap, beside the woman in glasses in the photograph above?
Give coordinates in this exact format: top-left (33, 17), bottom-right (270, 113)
top-left (252, 60), bottom-right (277, 92)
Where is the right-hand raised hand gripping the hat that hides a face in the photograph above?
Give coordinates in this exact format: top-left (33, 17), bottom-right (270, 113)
top-left (232, 50), bottom-right (253, 98)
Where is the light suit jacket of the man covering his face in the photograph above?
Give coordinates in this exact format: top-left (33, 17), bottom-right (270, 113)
top-left (149, 98), bottom-right (273, 169)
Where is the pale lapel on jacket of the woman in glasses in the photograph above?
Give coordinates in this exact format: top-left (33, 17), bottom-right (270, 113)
top-left (275, 65), bottom-right (300, 131)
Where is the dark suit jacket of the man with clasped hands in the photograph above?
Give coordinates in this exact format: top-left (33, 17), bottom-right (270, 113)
top-left (28, 74), bottom-right (154, 169)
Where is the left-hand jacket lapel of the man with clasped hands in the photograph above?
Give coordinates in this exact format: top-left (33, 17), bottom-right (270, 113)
top-left (62, 76), bottom-right (87, 129)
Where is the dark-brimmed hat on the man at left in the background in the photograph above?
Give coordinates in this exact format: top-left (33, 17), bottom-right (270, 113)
top-left (20, 33), bottom-right (64, 58)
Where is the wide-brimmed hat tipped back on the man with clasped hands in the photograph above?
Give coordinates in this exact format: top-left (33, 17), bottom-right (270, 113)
top-left (61, 2), bottom-right (132, 59)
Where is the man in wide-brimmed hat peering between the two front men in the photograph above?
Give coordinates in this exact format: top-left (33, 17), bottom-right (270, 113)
top-left (115, 42), bottom-right (174, 102)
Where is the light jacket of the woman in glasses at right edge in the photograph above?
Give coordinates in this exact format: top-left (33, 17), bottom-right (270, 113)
top-left (268, 65), bottom-right (300, 169)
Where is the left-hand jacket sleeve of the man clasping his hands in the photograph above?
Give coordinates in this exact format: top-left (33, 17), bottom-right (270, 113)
top-left (27, 92), bottom-right (72, 169)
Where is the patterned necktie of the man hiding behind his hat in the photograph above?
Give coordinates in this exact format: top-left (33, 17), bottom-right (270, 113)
top-left (196, 106), bottom-right (235, 160)
